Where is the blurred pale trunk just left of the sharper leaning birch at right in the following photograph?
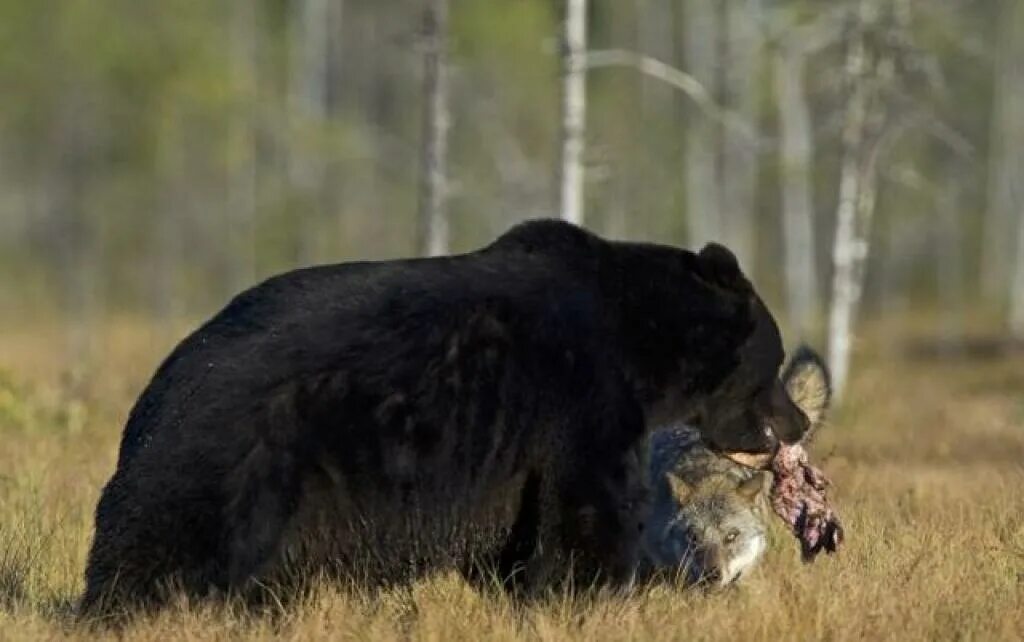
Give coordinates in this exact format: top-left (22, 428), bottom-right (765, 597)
top-left (774, 48), bottom-right (818, 336)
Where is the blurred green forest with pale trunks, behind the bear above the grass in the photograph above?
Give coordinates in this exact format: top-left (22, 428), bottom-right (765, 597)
top-left (0, 0), bottom-right (1024, 397)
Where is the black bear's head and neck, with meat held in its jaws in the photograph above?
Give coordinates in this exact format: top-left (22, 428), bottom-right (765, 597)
top-left (621, 238), bottom-right (810, 467)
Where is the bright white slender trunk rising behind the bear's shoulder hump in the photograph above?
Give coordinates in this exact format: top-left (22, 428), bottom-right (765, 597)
top-left (558, 0), bottom-right (587, 224)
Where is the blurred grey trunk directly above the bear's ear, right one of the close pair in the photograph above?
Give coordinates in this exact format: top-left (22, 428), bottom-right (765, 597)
top-left (720, 0), bottom-right (763, 275)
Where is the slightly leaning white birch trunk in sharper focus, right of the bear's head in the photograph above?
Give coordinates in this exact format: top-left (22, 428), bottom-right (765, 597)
top-left (828, 0), bottom-right (874, 397)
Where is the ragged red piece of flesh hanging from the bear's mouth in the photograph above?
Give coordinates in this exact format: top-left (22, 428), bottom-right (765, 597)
top-left (771, 443), bottom-right (843, 561)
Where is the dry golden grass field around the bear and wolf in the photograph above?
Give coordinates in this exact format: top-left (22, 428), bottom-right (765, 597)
top-left (0, 323), bottom-right (1024, 641)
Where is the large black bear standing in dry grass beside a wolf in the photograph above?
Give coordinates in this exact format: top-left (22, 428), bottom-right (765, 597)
top-left (81, 220), bottom-right (807, 615)
